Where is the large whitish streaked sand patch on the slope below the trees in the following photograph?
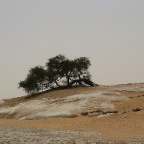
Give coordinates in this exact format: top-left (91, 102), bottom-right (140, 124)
top-left (0, 92), bottom-right (128, 119)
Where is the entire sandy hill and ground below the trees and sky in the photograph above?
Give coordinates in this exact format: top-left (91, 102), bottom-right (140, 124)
top-left (0, 84), bottom-right (144, 144)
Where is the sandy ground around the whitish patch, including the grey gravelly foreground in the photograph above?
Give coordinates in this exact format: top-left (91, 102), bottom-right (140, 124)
top-left (0, 84), bottom-right (144, 144)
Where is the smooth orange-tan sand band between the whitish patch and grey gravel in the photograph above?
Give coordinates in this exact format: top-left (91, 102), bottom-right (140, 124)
top-left (0, 111), bottom-right (144, 142)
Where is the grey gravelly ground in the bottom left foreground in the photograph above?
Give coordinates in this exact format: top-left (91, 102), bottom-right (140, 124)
top-left (0, 126), bottom-right (104, 144)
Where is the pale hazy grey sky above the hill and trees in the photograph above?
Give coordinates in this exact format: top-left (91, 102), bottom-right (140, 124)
top-left (0, 0), bottom-right (144, 99)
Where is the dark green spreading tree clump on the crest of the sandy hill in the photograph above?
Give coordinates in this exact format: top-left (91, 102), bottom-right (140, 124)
top-left (19, 54), bottom-right (96, 94)
